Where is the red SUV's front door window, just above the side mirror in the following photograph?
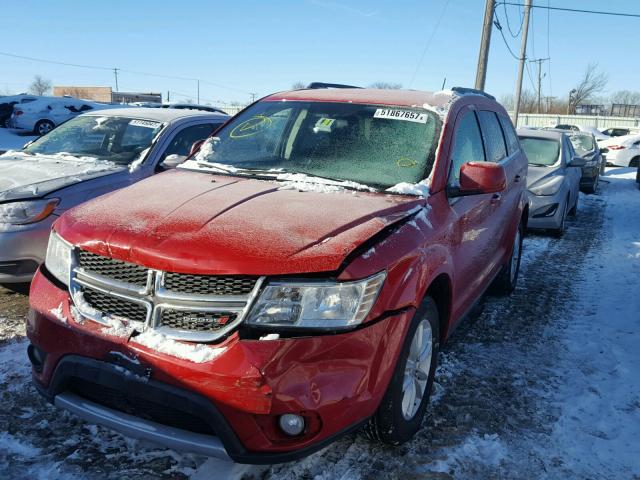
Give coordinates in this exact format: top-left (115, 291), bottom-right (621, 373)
top-left (449, 111), bottom-right (485, 186)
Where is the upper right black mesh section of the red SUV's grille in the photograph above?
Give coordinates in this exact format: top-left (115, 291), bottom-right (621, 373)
top-left (164, 272), bottom-right (258, 295)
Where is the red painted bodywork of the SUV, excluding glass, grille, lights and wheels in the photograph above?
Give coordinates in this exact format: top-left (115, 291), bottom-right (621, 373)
top-left (28, 89), bottom-right (527, 460)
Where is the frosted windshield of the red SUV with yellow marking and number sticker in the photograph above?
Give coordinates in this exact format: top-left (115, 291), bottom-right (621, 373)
top-left (190, 101), bottom-right (441, 188)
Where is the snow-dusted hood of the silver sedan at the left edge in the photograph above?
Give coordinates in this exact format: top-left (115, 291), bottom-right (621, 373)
top-left (0, 152), bottom-right (125, 202)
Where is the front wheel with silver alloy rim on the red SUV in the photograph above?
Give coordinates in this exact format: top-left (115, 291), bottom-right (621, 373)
top-left (364, 296), bottom-right (440, 445)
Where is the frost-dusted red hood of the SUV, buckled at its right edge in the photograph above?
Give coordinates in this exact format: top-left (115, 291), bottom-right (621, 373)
top-left (54, 170), bottom-right (425, 275)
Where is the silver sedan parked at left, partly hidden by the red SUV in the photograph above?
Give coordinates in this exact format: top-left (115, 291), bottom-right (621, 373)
top-left (0, 108), bottom-right (229, 284)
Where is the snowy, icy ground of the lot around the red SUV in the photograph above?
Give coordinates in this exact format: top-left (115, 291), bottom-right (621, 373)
top-left (0, 169), bottom-right (640, 480)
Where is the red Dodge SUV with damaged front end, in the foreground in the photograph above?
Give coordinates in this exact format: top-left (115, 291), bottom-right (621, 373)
top-left (28, 88), bottom-right (527, 463)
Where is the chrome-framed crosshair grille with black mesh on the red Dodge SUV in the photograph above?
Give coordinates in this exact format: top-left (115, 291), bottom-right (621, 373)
top-left (69, 249), bottom-right (264, 342)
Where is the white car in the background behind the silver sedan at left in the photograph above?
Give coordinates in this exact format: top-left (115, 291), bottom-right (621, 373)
top-left (8, 97), bottom-right (122, 135)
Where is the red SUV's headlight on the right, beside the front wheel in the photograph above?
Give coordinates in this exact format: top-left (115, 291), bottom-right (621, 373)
top-left (247, 272), bottom-right (386, 330)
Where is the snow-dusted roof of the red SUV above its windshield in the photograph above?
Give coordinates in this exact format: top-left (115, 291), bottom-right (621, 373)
top-left (263, 88), bottom-right (460, 108)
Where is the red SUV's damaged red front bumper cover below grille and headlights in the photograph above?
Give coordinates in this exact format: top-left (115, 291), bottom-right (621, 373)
top-left (27, 273), bottom-right (413, 463)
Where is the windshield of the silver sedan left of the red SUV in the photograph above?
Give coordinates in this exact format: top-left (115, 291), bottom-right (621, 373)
top-left (24, 115), bottom-right (163, 165)
